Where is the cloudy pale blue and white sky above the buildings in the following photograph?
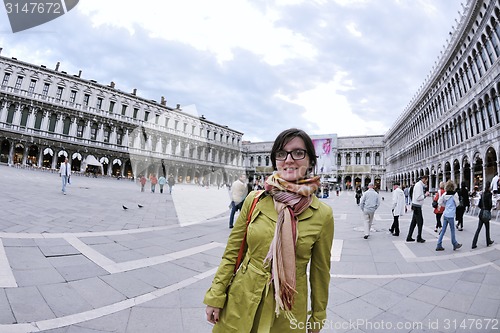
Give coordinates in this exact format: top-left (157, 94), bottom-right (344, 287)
top-left (0, 0), bottom-right (467, 142)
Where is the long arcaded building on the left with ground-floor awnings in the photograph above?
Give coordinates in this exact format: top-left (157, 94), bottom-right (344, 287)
top-left (0, 49), bottom-right (243, 184)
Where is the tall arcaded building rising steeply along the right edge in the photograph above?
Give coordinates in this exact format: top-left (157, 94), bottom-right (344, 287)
top-left (385, 0), bottom-right (500, 189)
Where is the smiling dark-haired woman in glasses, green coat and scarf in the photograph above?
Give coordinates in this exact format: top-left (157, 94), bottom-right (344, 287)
top-left (204, 129), bottom-right (333, 333)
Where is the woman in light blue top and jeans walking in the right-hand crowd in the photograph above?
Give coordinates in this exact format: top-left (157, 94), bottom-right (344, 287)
top-left (436, 179), bottom-right (462, 251)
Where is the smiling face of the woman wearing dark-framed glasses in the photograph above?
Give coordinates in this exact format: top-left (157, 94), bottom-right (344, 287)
top-left (276, 137), bottom-right (309, 182)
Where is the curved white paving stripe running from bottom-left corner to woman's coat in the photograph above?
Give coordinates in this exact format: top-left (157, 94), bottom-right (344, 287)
top-left (0, 267), bottom-right (221, 333)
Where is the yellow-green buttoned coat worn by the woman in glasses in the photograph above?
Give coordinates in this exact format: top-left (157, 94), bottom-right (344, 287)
top-left (204, 192), bottom-right (334, 333)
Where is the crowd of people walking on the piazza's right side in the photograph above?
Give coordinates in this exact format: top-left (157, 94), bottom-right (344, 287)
top-left (364, 173), bottom-right (500, 251)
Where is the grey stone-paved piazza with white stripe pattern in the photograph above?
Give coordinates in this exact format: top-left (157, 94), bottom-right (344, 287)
top-left (0, 166), bottom-right (500, 333)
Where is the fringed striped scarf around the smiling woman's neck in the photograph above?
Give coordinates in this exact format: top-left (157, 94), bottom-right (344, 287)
top-left (264, 173), bottom-right (320, 319)
